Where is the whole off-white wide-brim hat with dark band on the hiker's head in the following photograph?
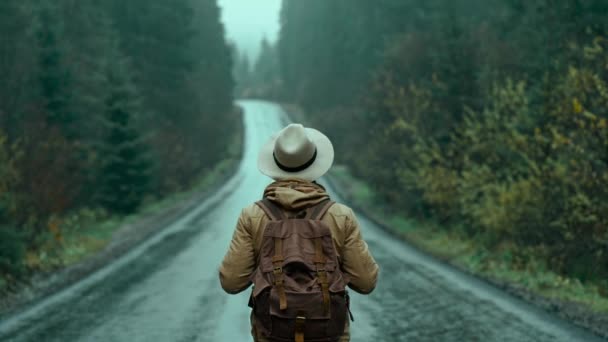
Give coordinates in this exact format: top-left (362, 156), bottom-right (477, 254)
top-left (258, 124), bottom-right (334, 181)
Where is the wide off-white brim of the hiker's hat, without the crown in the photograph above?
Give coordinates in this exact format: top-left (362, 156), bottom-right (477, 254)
top-left (258, 128), bottom-right (334, 181)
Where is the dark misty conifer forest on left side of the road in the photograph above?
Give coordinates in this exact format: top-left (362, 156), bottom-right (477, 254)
top-left (0, 0), bottom-right (239, 275)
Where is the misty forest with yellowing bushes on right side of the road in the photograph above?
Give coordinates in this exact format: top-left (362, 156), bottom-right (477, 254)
top-left (278, 0), bottom-right (608, 281)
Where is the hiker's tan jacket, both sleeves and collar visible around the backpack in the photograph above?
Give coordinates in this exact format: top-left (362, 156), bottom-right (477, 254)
top-left (220, 180), bottom-right (378, 340)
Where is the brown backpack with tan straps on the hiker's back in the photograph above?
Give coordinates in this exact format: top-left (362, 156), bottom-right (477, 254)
top-left (250, 199), bottom-right (348, 342)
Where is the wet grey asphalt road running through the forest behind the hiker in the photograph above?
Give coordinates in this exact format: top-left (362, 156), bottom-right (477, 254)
top-left (0, 101), bottom-right (603, 342)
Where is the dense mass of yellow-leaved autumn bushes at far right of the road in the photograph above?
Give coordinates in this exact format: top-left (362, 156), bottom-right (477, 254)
top-left (454, 39), bottom-right (608, 279)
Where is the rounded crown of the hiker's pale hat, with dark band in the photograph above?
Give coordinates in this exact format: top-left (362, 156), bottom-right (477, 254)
top-left (274, 124), bottom-right (317, 168)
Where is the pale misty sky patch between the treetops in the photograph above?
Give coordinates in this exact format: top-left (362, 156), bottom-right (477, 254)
top-left (218, 0), bottom-right (281, 58)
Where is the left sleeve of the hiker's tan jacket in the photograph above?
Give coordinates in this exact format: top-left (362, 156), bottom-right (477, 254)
top-left (219, 211), bottom-right (255, 294)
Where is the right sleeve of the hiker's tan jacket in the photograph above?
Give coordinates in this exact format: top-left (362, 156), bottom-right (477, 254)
top-left (342, 211), bottom-right (379, 294)
